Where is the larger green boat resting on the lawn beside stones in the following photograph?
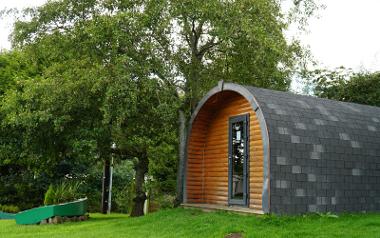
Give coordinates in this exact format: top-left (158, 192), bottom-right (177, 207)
top-left (15, 198), bottom-right (87, 225)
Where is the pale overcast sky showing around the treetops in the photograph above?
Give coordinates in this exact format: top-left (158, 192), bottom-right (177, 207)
top-left (0, 0), bottom-right (380, 71)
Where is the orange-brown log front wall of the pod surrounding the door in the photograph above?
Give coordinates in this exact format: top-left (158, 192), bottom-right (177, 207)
top-left (186, 91), bottom-right (264, 211)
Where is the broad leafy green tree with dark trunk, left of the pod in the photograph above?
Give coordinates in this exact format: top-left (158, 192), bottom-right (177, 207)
top-left (2, 0), bottom-right (177, 216)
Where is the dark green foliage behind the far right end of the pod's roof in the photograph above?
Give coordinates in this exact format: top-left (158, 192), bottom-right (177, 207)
top-left (313, 68), bottom-right (380, 106)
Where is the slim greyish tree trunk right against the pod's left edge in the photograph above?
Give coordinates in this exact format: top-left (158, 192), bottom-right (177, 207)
top-left (174, 110), bottom-right (187, 206)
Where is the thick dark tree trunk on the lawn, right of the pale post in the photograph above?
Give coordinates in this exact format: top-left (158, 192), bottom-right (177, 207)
top-left (130, 156), bottom-right (149, 217)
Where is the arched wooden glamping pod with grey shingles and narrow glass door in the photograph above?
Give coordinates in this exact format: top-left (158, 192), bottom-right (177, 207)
top-left (183, 82), bottom-right (380, 214)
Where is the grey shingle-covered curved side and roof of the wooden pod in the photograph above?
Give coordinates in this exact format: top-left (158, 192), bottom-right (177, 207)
top-left (246, 86), bottom-right (380, 213)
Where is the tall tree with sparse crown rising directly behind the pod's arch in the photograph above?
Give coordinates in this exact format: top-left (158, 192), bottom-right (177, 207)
top-left (158, 0), bottom-right (318, 203)
